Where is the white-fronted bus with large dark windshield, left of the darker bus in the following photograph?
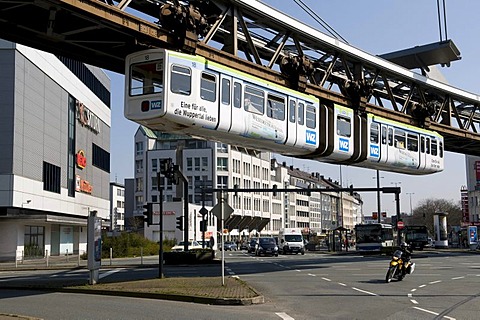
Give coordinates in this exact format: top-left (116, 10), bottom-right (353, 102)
top-left (355, 223), bottom-right (394, 252)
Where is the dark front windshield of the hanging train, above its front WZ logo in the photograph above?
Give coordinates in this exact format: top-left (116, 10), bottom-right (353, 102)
top-left (130, 60), bottom-right (163, 96)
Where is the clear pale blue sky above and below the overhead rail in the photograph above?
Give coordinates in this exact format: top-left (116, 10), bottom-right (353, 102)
top-left (107, 0), bottom-right (480, 215)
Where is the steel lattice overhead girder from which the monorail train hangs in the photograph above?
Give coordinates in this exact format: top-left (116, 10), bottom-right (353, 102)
top-left (0, 0), bottom-right (480, 156)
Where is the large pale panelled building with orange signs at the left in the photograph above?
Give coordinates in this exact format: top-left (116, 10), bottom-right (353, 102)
top-left (0, 40), bottom-right (110, 260)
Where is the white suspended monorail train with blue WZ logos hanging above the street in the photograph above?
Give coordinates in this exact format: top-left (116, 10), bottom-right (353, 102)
top-left (125, 49), bottom-right (444, 175)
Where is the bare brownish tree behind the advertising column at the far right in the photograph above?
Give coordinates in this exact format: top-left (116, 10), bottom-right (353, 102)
top-left (405, 199), bottom-right (462, 235)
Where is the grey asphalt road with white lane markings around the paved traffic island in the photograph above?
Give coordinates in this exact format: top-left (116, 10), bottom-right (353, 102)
top-left (0, 252), bottom-right (480, 320)
